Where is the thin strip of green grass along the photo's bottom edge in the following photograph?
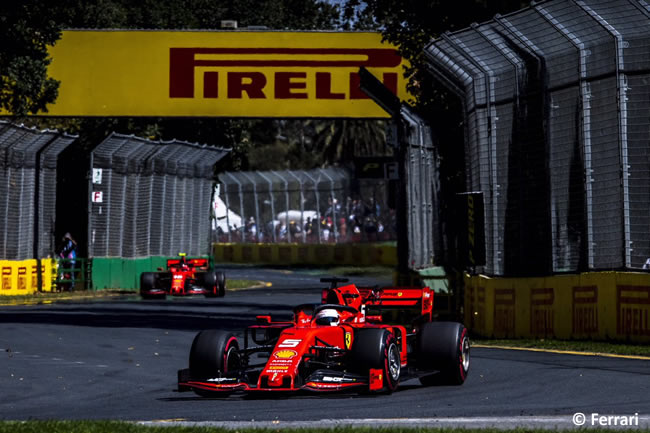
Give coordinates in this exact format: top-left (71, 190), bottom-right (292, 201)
top-left (0, 421), bottom-right (650, 433)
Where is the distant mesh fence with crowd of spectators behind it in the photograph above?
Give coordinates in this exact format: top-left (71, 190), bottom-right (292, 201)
top-left (214, 167), bottom-right (396, 243)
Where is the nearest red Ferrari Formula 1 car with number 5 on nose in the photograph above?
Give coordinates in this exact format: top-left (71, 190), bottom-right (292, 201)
top-left (178, 279), bottom-right (469, 397)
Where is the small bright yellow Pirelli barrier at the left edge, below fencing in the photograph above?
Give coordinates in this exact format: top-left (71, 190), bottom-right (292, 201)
top-left (0, 259), bottom-right (56, 296)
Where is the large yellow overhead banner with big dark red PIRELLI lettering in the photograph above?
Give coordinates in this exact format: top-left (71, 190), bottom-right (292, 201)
top-left (40, 30), bottom-right (407, 118)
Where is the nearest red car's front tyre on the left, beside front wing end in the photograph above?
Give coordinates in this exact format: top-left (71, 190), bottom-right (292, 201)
top-left (190, 329), bottom-right (241, 380)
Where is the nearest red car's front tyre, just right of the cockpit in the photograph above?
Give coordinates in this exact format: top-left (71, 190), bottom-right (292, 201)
top-left (351, 328), bottom-right (401, 394)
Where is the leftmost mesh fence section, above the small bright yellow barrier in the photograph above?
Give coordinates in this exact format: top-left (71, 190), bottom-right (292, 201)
top-left (0, 121), bottom-right (77, 260)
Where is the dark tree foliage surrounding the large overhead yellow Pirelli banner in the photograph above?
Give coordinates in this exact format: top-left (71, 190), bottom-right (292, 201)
top-left (0, 0), bottom-right (522, 170)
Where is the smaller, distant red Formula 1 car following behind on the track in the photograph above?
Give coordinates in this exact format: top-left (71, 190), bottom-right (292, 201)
top-left (140, 254), bottom-right (226, 299)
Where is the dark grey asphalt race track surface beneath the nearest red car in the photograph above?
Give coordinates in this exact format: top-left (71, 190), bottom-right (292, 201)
top-left (0, 268), bottom-right (650, 428)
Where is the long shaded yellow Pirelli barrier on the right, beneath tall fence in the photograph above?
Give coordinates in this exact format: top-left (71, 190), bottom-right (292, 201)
top-left (465, 272), bottom-right (650, 342)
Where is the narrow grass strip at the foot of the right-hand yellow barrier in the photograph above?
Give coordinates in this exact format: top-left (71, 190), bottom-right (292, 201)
top-left (472, 338), bottom-right (650, 357)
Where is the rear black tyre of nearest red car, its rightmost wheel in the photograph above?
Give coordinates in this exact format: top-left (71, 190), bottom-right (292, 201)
top-left (417, 322), bottom-right (470, 385)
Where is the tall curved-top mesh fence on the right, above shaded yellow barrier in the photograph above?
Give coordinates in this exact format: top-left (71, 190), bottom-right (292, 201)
top-left (425, 0), bottom-right (650, 275)
